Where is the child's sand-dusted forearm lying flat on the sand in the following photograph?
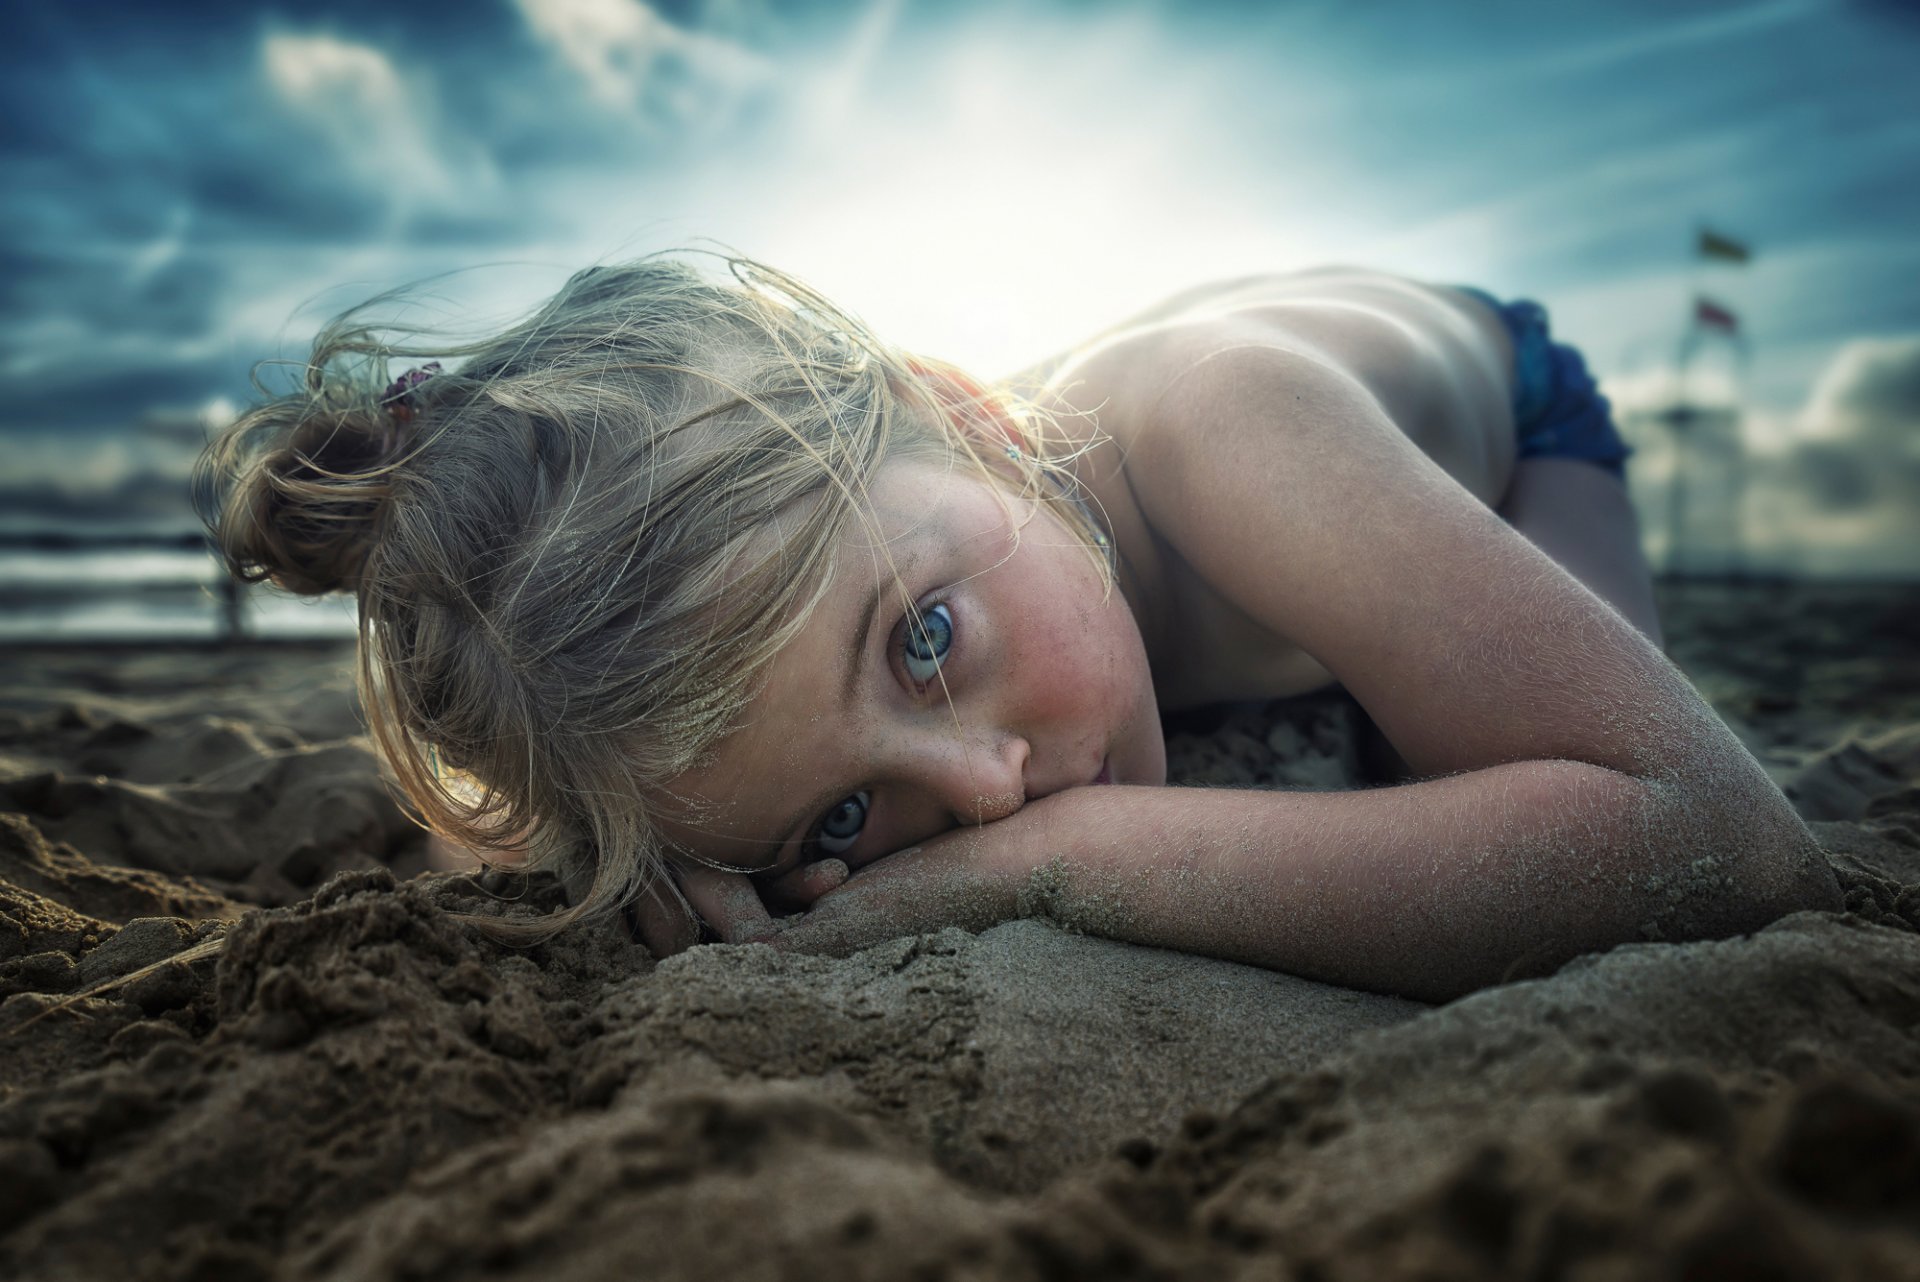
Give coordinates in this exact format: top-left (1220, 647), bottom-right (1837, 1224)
top-left (1020, 762), bottom-right (1837, 1000)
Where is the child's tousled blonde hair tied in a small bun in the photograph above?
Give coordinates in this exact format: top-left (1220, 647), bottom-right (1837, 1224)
top-left (200, 255), bottom-right (1112, 938)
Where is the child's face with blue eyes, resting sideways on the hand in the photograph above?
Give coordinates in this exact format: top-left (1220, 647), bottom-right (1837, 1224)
top-left (666, 459), bottom-right (1167, 886)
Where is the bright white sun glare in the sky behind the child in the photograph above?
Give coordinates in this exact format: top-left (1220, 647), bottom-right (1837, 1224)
top-left (606, 19), bottom-right (1331, 374)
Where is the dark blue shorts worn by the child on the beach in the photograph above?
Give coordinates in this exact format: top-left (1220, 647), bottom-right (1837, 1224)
top-left (1453, 284), bottom-right (1634, 480)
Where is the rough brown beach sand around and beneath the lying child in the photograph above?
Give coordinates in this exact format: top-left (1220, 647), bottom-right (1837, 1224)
top-left (0, 585), bottom-right (1920, 1282)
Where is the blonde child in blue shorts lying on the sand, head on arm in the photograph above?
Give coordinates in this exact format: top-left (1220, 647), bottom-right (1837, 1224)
top-left (198, 257), bottom-right (1839, 1000)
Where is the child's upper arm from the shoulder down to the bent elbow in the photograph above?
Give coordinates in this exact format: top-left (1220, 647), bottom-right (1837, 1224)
top-left (1125, 344), bottom-right (1705, 775)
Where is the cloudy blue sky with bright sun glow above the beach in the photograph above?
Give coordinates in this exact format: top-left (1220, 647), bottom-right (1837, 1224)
top-left (0, 0), bottom-right (1920, 576)
